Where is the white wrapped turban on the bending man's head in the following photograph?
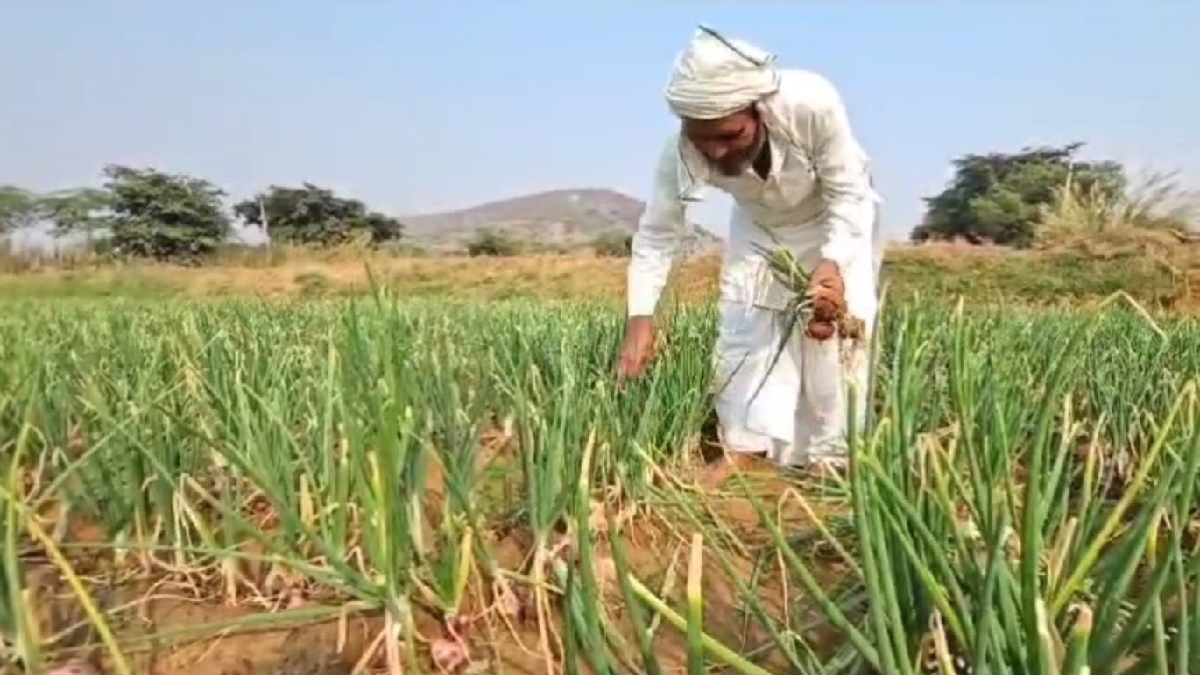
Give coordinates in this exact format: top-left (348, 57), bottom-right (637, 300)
top-left (666, 28), bottom-right (779, 120)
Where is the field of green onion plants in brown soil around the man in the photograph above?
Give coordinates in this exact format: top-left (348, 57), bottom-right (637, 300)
top-left (0, 292), bottom-right (1200, 675)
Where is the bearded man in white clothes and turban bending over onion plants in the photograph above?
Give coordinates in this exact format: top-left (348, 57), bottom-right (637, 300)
top-left (618, 28), bottom-right (882, 482)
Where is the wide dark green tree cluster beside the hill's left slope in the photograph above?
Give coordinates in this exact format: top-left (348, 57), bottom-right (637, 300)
top-left (233, 183), bottom-right (403, 246)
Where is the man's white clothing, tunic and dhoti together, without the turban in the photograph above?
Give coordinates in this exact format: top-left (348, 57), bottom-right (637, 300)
top-left (628, 70), bottom-right (882, 465)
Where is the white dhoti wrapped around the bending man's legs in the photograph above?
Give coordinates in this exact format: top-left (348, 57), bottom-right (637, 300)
top-left (714, 205), bottom-right (882, 466)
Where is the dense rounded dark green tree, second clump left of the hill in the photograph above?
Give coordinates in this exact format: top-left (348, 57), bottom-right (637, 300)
top-left (104, 165), bottom-right (232, 263)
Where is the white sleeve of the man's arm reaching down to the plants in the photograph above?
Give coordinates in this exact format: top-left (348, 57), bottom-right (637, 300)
top-left (628, 138), bottom-right (686, 317)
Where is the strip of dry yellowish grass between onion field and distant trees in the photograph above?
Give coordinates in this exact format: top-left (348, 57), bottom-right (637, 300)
top-left (0, 235), bottom-right (1200, 309)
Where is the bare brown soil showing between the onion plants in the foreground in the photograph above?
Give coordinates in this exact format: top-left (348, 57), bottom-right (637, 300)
top-left (9, 435), bottom-right (846, 675)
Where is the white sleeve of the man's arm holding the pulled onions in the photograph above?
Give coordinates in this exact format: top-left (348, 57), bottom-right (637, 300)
top-left (809, 75), bottom-right (877, 271)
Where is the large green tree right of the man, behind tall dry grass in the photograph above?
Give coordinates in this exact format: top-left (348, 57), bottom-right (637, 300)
top-left (912, 143), bottom-right (1127, 246)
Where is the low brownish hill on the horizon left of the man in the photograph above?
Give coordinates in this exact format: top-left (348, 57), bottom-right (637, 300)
top-left (401, 187), bottom-right (719, 250)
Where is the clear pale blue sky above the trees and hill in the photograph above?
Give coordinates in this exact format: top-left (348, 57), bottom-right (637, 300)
top-left (0, 0), bottom-right (1200, 235)
